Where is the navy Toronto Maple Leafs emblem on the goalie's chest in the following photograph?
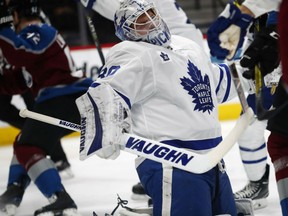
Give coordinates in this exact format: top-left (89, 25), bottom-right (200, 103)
top-left (180, 61), bottom-right (214, 114)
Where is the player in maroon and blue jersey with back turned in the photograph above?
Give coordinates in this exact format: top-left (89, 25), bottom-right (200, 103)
top-left (0, 0), bottom-right (92, 213)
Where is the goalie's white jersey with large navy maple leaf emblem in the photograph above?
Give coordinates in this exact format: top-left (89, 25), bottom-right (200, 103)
top-left (96, 35), bottom-right (236, 150)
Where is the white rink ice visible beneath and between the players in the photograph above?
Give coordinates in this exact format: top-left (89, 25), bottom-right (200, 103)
top-left (0, 121), bottom-right (281, 216)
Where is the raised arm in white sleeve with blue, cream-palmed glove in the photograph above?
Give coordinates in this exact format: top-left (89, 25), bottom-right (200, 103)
top-left (207, 0), bottom-right (280, 60)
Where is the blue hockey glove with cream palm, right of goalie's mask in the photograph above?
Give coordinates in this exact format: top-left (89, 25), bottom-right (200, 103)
top-left (207, 2), bottom-right (253, 60)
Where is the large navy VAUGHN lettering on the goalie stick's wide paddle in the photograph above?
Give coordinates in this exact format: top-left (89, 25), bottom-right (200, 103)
top-left (126, 137), bottom-right (193, 166)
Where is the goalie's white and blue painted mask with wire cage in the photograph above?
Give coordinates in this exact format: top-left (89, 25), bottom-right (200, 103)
top-left (114, 0), bottom-right (171, 47)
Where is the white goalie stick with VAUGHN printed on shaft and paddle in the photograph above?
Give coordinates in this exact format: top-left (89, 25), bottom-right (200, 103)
top-left (19, 109), bottom-right (253, 174)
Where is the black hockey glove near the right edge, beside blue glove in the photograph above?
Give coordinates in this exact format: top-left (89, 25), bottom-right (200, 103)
top-left (240, 25), bottom-right (280, 79)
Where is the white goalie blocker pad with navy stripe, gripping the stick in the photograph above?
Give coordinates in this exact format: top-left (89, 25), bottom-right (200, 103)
top-left (76, 83), bottom-right (131, 160)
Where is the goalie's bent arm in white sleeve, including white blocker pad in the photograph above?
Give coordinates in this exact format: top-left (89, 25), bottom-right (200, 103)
top-left (76, 42), bottom-right (154, 159)
